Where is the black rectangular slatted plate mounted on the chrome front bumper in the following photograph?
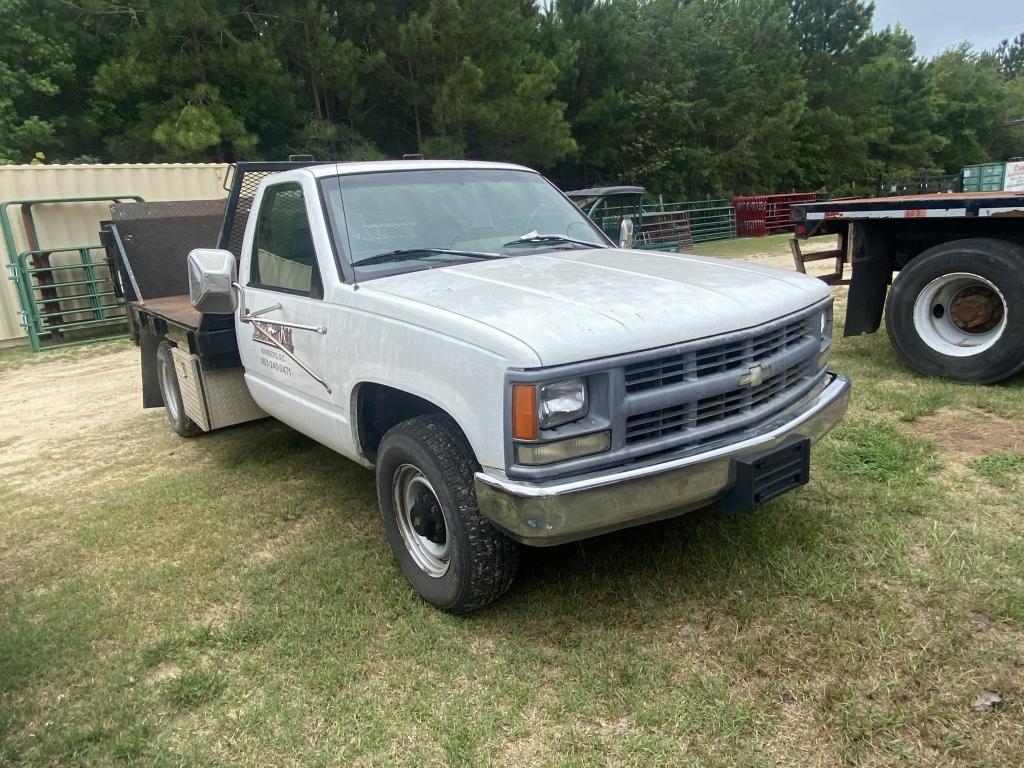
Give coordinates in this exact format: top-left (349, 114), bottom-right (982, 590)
top-left (719, 437), bottom-right (811, 512)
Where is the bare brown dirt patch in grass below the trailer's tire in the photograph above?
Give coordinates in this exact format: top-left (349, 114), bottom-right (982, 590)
top-left (904, 409), bottom-right (1024, 464)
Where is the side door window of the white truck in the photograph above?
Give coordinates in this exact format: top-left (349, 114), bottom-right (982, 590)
top-left (249, 183), bottom-right (324, 298)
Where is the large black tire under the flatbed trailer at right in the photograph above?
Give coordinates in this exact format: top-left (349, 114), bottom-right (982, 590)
top-left (886, 238), bottom-right (1024, 384)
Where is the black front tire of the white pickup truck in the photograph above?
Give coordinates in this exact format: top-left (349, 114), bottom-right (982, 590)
top-left (377, 414), bottom-right (519, 613)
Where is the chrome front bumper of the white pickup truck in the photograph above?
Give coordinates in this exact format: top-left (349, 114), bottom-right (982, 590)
top-left (476, 373), bottom-right (850, 547)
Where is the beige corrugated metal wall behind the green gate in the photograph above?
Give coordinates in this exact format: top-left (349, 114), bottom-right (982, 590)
top-left (0, 163), bottom-right (229, 345)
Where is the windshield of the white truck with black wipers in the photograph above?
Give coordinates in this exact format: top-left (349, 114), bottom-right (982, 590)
top-left (321, 169), bottom-right (609, 280)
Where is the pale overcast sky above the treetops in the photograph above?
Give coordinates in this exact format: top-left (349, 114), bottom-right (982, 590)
top-left (874, 0), bottom-right (1024, 58)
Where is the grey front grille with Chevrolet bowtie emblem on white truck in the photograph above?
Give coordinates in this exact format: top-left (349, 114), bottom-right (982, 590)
top-left (624, 307), bottom-right (824, 453)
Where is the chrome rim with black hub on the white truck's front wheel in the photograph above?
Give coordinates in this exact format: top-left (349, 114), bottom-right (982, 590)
top-left (391, 464), bottom-right (452, 579)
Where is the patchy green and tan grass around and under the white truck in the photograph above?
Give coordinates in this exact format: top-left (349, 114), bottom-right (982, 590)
top-left (0, 276), bottom-right (1024, 767)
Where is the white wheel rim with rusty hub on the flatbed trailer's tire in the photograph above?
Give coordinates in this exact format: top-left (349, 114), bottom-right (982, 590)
top-left (913, 272), bottom-right (1008, 357)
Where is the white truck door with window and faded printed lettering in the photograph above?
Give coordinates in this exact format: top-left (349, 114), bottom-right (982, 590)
top-left (238, 181), bottom-right (340, 445)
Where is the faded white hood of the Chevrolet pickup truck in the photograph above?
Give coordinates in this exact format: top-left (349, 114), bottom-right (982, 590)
top-left (360, 249), bottom-right (830, 366)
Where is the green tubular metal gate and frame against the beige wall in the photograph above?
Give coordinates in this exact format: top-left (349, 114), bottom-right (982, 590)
top-left (0, 195), bottom-right (142, 352)
